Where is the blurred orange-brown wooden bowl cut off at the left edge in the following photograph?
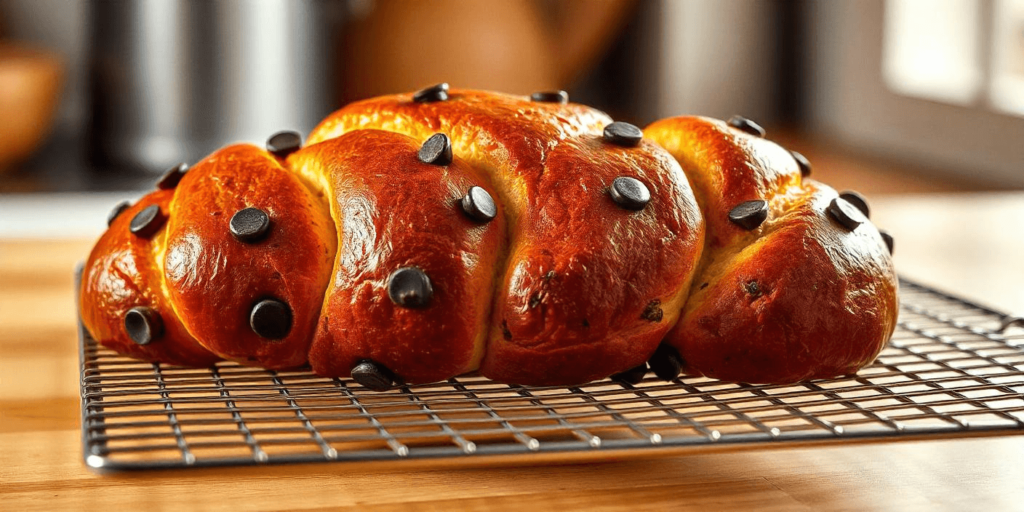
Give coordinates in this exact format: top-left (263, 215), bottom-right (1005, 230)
top-left (0, 42), bottom-right (63, 172)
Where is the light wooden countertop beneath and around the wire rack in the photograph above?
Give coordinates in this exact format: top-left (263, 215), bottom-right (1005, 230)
top-left (0, 193), bottom-right (1024, 511)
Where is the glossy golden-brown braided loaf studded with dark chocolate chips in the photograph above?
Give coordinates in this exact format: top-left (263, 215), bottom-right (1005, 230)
top-left (80, 84), bottom-right (897, 389)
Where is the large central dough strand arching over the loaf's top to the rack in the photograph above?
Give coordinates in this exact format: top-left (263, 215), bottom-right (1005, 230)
top-left (310, 91), bottom-right (702, 385)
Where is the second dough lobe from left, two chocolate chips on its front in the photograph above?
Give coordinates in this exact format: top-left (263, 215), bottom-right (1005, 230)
top-left (163, 145), bottom-right (336, 369)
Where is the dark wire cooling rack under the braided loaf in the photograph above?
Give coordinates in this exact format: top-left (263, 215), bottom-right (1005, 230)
top-left (80, 281), bottom-right (1024, 470)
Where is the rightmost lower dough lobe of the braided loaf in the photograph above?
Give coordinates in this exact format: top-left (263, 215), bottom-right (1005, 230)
top-left (667, 185), bottom-right (898, 383)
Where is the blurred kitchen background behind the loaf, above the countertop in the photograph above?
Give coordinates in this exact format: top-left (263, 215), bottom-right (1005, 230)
top-left (0, 0), bottom-right (1024, 226)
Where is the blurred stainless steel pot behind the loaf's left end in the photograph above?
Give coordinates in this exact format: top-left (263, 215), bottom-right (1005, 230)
top-left (88, 0), bottom-right (333, 173)
